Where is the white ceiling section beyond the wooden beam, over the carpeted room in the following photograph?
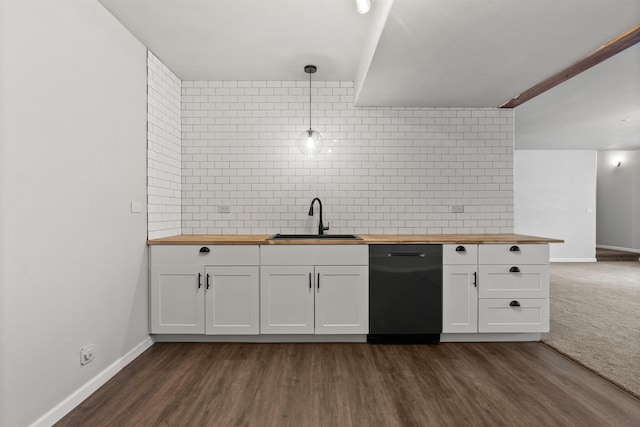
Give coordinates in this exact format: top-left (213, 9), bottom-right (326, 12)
top-left (515, 43), bottom-right (640, 150)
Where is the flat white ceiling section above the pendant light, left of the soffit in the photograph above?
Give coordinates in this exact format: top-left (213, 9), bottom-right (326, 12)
top-left (100, 0), bottom-right (375, 80)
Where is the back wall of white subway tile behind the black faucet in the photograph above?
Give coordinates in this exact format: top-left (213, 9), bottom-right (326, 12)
top-left (182, 81), bottom-right (513, 234)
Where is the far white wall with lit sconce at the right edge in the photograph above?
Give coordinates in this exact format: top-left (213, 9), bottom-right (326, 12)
top-left (597, 151), bottom-right (640, 252)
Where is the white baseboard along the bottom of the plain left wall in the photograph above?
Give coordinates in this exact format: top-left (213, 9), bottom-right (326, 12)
top-left (31, 337), bottom-right (153, 427)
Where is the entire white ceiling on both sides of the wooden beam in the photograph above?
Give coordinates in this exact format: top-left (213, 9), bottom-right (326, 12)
top-left (99, 0), bottom-right (640, 149)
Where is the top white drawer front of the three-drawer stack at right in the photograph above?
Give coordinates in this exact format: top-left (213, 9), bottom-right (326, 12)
top-left (478, 243), bottom-right (549, 265)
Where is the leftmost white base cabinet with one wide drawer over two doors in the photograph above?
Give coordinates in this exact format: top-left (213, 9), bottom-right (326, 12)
top-left (150, 245), bottom-right (260, 335)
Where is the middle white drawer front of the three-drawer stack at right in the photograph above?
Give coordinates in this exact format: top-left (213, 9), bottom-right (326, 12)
top-left (478, 264), bottom-right (549, 298)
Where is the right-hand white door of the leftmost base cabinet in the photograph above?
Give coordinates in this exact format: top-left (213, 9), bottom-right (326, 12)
top-left (205, 267), bottom-right (260, 335)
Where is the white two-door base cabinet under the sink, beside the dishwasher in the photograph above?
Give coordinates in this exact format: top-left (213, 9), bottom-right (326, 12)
top-left (260, 245), bottom-right (369, 335)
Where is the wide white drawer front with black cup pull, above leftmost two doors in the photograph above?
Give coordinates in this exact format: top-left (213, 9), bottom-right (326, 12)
top-left (151, 245), bottom-right (260, 265)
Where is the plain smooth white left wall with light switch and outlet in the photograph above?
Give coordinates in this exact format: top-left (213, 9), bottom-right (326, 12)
top-left (0, 0), bottom-right (148, 427)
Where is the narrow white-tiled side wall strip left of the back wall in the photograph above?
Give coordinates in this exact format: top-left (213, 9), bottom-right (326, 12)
top-left (147, 51), bottom-right (182, 239)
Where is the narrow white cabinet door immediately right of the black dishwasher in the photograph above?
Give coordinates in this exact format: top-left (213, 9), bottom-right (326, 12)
top-left (442, 265), bottom-right (478, 333)
